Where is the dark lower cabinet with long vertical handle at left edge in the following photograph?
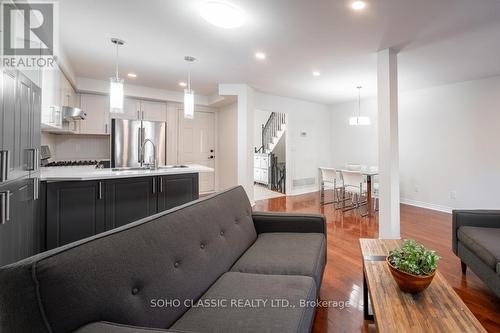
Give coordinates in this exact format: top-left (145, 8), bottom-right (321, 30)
top-left (0, 178), bottom-right (42, 266)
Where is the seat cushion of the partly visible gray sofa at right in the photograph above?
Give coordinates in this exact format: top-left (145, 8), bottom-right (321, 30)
top-left (457, 226), bottom-right (500, 273)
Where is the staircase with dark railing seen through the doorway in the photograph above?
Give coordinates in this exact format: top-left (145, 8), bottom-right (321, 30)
top-left (255, 112), bottom-right (286, 194)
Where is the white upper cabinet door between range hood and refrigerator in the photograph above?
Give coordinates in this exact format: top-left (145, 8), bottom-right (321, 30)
top-left (79, 94), bottom-right (111, 134)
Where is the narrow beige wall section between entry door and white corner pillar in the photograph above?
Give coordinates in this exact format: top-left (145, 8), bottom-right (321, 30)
top-left (216, 103), bottom-right (238, 190)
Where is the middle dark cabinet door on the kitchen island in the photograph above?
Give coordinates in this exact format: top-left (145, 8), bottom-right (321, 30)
top-left (105, 177), bottom-right (157, 230)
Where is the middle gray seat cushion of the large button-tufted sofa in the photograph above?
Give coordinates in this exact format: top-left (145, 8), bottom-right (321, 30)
top-left (170, 272), bottom-right (316, 333)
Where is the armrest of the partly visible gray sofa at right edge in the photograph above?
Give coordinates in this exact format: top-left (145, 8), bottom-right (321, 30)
top-left (451, 210), bottom-right (500, 254)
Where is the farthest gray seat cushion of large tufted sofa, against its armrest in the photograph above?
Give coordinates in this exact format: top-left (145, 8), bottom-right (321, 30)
top-left (231, 233), bottom-right (326, 286)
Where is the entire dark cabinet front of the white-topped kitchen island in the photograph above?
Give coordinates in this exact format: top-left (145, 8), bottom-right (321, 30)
top-left (42, 173), bottom-right (198, 250)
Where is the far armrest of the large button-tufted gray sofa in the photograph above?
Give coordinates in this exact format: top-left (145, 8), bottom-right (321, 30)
top-left (252, 212), bottom-right (326, 233)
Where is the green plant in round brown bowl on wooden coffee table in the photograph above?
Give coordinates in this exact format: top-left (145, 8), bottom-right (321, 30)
top-left (387, 240), bottom-right (441, 294)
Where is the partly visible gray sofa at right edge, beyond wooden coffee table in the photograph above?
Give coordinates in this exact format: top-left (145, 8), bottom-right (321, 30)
top-left (452, 210), bottom-right (500, 297)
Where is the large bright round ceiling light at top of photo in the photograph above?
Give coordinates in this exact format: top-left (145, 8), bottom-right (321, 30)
top-left (200, 1), bottom-right (246, 29)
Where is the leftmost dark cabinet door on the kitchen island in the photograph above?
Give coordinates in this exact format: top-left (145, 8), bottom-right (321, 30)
top-left (45, 181), bottom-right (105, 250)
